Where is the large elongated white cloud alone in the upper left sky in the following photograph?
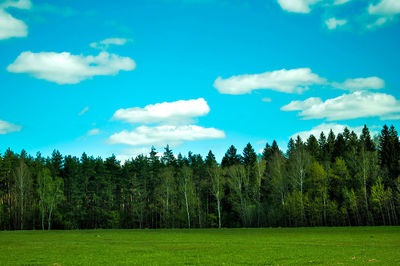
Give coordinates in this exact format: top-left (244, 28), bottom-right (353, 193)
top-left (7, 51), bottom-right (136, 84)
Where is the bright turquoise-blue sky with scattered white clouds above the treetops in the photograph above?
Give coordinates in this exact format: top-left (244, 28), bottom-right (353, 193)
top-left (0, 0), bottom-right (400, 161)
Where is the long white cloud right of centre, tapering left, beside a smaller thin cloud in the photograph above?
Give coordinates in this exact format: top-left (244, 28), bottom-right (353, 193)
top-left (214, 68), bottom-right (325, 95)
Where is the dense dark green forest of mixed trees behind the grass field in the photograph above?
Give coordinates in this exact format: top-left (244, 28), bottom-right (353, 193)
top-left (0, 125), bottom-right (400, 230)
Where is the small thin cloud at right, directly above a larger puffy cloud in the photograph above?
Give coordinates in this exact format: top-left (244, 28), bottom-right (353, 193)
top-left (332, 77), bottom-right (385, 91)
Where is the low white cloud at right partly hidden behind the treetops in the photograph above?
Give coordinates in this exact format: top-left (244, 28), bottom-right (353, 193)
top-left (291, 123), bottom-right (378, 140)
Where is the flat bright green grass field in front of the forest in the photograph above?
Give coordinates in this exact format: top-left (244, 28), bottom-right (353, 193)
top-left (0, 227), bottom-right (400, 265)
